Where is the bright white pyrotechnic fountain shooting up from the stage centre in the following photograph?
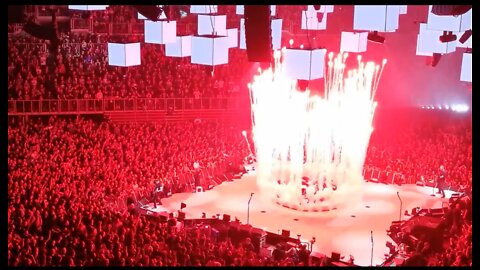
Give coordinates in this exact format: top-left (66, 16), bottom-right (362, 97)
top-left (249, 51), bottom-right (386, 211)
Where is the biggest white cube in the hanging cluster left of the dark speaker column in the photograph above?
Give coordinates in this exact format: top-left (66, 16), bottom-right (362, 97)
top-left (191, 36), bottom-right (229, 66)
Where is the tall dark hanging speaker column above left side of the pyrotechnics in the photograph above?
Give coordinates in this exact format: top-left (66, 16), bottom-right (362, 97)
top-left (245, 5), bottom-right (272, 62)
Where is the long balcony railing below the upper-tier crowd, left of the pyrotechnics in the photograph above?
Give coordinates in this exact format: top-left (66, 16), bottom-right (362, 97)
top-left (8, 98), bottom-right (245, 115)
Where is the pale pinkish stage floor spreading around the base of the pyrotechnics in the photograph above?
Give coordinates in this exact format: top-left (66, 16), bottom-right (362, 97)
top-left (143, 172), bottom-right (452, 266)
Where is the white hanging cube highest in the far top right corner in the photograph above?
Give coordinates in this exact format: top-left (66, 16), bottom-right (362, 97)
top-left (427, 5), bottom-right (472, 32)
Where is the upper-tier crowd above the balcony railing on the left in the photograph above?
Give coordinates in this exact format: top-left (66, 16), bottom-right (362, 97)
top-left (8, 26), bottom-right (252, 100)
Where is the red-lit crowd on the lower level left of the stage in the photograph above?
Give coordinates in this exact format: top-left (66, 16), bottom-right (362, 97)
top-left (8, 118), bottom-right (255, 265)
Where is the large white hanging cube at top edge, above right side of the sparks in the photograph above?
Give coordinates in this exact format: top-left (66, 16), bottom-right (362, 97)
top-left (353, 5), bottom-right (400, 32)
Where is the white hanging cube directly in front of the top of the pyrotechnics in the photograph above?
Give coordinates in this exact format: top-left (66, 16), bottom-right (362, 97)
top-left (283, 49), bottom-right (327, 80)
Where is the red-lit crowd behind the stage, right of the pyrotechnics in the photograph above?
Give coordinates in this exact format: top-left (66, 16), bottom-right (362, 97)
top-left (365, 112), bottom-right (472, 191)
